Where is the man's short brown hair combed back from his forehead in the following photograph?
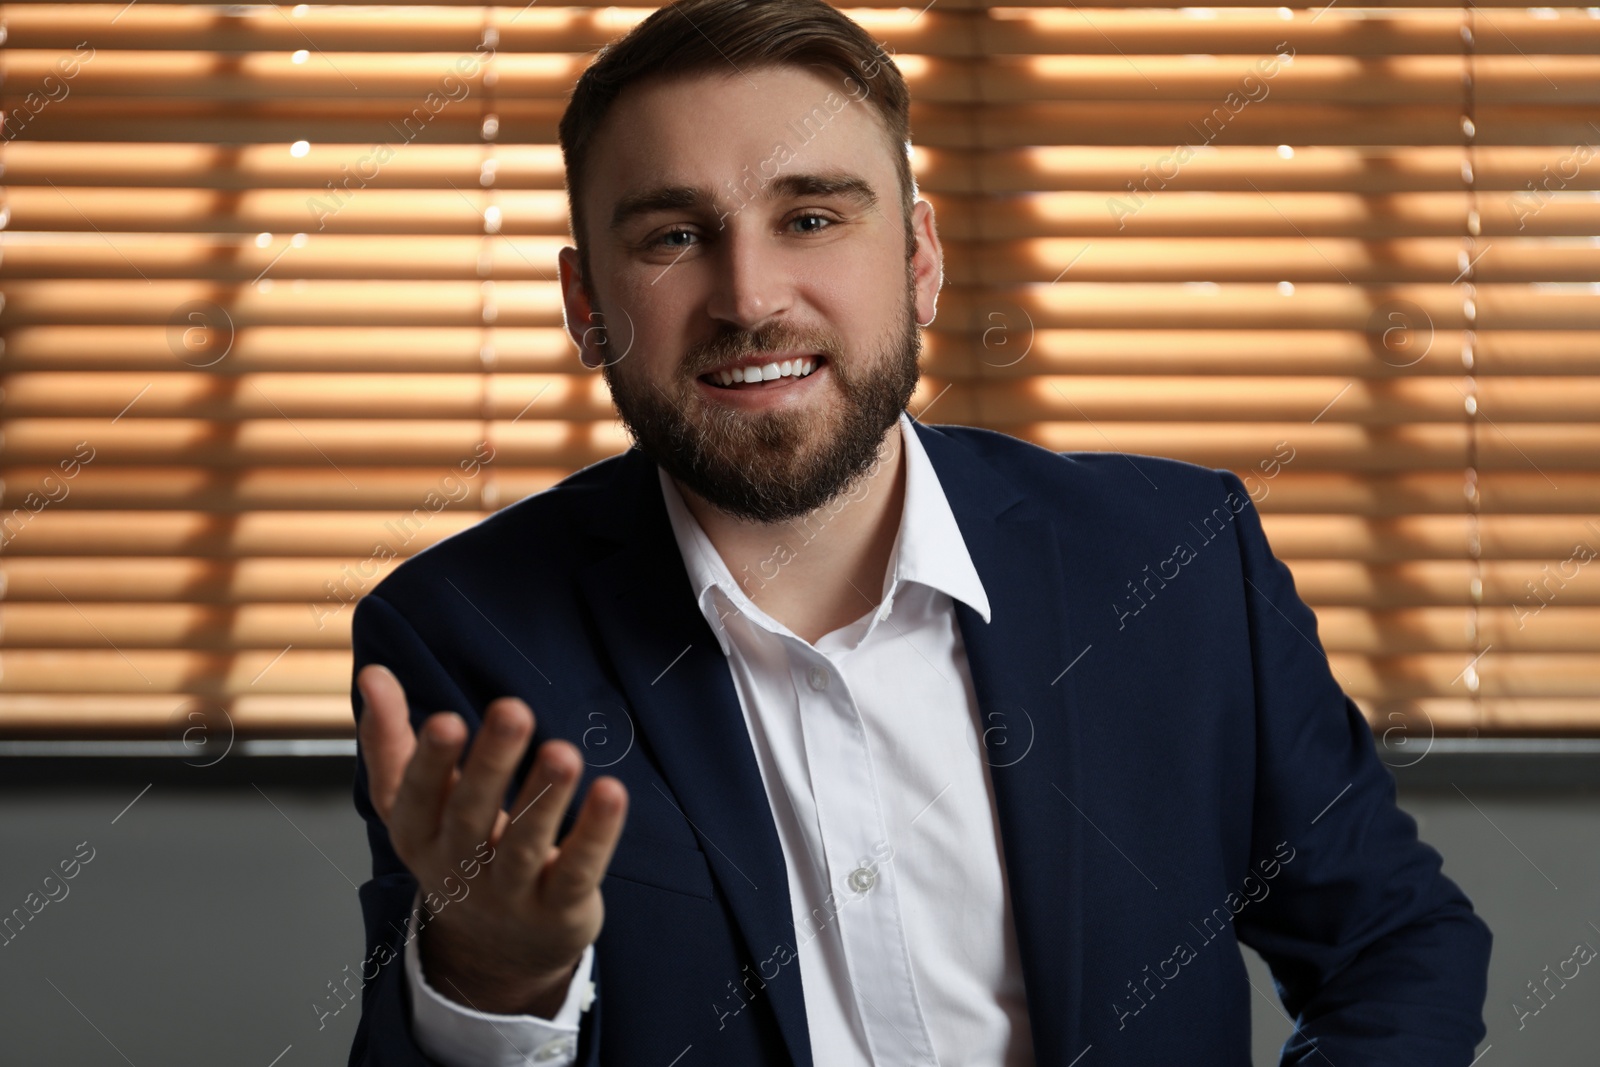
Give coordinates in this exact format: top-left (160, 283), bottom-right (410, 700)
top-left (560, 0), bottom-right (917, 296)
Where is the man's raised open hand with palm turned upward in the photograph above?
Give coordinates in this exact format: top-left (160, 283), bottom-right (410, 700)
top-left (355, 664), bottom-right (627, 1019)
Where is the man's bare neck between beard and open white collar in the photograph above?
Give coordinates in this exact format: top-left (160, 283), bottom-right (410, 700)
top-left (674, 422), bottom-right (906, 645)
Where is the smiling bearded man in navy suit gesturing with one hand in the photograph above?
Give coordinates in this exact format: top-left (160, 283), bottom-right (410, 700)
top-left (350, 0), bottom-right (1490, 1067)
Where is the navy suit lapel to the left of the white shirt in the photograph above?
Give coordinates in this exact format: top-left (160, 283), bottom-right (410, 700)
top-left (578, 448), bottom-right (811, 1065)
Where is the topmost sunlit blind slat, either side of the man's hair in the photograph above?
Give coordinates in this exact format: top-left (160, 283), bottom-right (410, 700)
top-left (6, 3), bottom-right (1600, 56)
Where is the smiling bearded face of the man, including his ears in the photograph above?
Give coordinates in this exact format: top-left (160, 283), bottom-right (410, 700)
top-left (562, 67), bottom-right (941, 523)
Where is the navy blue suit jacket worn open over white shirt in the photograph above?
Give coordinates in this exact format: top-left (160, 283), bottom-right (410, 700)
top-left (350, 424), bottom-right (1490, 1067)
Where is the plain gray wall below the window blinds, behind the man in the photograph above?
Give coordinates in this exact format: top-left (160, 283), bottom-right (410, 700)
top-left (0, 757), bottom-right (1600, 1067)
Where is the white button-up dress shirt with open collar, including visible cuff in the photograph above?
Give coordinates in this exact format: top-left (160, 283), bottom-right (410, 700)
top-left (405, 413), bottom-right (1034, 1067)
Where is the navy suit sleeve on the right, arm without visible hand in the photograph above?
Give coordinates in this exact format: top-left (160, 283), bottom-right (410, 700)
top-left (1219, 470), bottom-right (1491, 1067)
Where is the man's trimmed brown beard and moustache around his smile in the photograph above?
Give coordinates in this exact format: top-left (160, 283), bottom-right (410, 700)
top-left (605, 272), bottom-right (922, 523)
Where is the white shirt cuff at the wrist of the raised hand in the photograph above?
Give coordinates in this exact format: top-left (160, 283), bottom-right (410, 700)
top-left (405, 891), bottom-right (595, 1067)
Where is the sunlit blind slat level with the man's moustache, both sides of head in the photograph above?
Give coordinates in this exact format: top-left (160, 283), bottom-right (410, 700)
top-left (5, 326), bottom-right (1600, 381)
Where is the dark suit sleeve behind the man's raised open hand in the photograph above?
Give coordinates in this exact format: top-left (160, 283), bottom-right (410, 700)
top-left (349, 593), bottom-right (600, 1067)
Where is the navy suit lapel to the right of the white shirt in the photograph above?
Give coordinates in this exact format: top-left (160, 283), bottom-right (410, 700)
top-left (914, 422), bottom-right (1085, 1064)
